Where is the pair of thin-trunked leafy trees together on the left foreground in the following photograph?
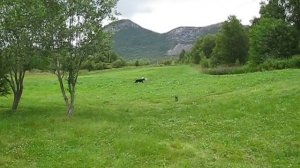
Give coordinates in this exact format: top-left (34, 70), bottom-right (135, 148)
top-left (0, 0), bottom-right (117, 117)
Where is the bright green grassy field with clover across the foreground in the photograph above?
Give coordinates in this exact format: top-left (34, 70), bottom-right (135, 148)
top-left (0, 66), bottom-right (300, 168)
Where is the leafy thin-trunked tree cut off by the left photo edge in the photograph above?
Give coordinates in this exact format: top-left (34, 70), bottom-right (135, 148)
top-left (0, 0), bottom-right (42, 111)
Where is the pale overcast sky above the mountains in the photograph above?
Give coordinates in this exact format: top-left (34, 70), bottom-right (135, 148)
top-left (117, 0), bottom-right (261, 33)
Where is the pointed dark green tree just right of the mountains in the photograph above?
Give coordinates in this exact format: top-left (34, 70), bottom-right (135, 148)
top-left (212, 16), bottom-right (249, 65)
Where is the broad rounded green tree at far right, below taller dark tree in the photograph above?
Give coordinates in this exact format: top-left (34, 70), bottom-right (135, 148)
top-left (249, 18), bottom-right (298, 65)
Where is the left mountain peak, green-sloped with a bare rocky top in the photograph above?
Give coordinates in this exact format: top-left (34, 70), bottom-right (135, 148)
top-left (105, 20), bottom-right (173, 60)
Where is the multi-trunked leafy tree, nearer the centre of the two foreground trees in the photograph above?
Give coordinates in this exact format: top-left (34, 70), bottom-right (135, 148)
top-left (43, 0), bottom-right (117, 117)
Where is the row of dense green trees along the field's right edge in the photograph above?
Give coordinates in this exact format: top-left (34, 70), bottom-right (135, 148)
top-left (179, 0), bottom-right (300, 68)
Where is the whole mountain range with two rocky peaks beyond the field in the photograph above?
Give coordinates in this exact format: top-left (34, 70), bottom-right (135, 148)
top-left (105, 20), bottom-right (222, 60)
